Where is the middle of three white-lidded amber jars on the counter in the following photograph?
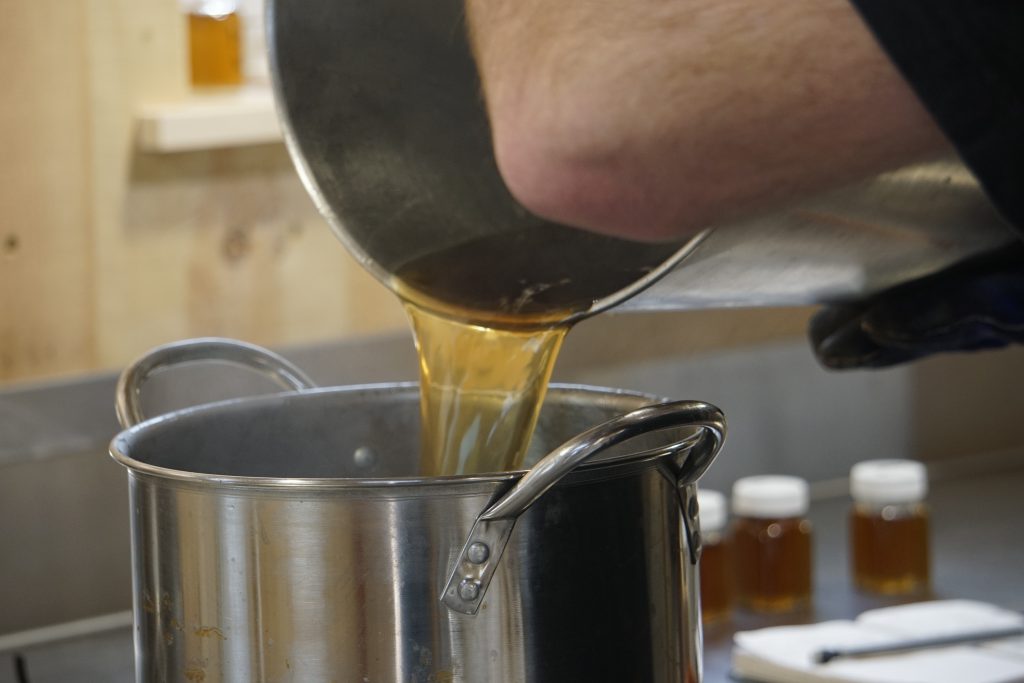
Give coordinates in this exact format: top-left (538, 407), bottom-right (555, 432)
top-left (731, 475), bottom-right (811, 612)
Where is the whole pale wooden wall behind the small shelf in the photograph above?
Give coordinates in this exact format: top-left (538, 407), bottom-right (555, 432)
top-left (0, 0), bottom-right (404, 382)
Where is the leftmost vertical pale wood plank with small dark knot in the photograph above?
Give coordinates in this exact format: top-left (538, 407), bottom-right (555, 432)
top-left (0, 0), bottom-right (94, 380)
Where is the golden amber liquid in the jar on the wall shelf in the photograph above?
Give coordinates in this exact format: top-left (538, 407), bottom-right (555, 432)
top-left (188, 12), bottom-right (242, 86)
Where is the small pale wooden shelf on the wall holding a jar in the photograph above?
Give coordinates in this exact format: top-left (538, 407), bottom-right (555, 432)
top-left (137, 87), bottom-right (282, 153)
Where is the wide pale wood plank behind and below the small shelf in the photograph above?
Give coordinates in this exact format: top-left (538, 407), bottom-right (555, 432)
top-left (84, 0), bottom-right (404, 368)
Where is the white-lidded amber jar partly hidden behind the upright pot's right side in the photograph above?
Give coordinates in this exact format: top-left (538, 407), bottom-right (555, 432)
top-left (697, 488), bottom-right (732, 624)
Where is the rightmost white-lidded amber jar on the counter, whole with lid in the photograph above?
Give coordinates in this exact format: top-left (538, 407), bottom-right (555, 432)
top-left (850, 460), bottom-right (931, 595)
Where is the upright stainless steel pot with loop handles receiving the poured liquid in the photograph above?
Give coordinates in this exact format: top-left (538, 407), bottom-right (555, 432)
top-left (111, 340), bottom-right (725, 683)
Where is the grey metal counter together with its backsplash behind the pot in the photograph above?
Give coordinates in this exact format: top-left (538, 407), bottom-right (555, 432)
top-left (0, 329), bottom-right (1024, 683)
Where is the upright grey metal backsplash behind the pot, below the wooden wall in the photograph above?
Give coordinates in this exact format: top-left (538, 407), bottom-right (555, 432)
top-left (0, 335), bottom-right (917, 637)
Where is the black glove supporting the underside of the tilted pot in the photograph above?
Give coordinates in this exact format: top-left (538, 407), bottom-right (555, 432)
top-left (810, 244), bottom-right (1024, 370)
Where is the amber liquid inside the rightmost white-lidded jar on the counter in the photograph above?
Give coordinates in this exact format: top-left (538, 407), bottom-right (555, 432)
top-left (850, 504), bottom-right (931, 595)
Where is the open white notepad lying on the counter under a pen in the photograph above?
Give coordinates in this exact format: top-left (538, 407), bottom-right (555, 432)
top-left (732, 600), bottom-right (1024, 683)
